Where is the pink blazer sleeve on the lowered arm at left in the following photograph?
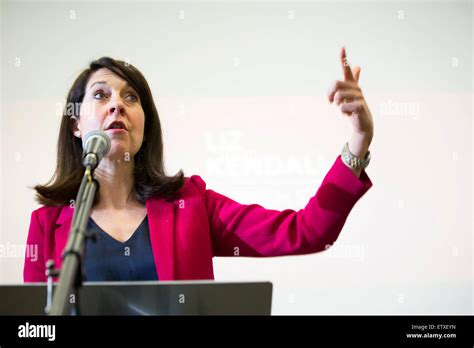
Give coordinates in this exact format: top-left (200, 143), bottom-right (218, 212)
top-left (23, 210), bottom-right (46, 283)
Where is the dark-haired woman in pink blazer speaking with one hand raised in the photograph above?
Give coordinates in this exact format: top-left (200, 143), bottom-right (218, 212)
top-left (24, 48), bottom-right (373, 282)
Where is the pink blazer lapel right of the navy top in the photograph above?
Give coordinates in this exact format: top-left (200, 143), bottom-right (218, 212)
top-left (146, 198), bottom-right (176, 280)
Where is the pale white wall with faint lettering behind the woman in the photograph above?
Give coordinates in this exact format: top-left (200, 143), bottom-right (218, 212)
top-left (0, 1), bottom-right (473, 314)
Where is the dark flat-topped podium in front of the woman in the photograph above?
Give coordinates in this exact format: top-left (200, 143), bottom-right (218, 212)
top-left (0, 280), bottom-right (272, 316)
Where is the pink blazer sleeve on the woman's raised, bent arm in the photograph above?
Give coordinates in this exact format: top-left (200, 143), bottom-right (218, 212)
top-left (191, 156), bottom-right (372, 257)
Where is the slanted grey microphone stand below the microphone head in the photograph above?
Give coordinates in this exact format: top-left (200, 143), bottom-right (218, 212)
top-left (47, 165), bottom-right (99, 315)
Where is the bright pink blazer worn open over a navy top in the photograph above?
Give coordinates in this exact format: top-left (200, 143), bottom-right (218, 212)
top-left (23, 156), bottom-right (372, 282)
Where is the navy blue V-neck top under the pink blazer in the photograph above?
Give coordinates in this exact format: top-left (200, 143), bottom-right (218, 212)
top-left (84, 216), bottom-right (158, 281)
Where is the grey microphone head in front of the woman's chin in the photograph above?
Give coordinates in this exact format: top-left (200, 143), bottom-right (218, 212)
top-left (82, 130), bottom-right (110, 169)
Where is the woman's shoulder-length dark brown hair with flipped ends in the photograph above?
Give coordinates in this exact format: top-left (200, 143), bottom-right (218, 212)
top-left (33, 57), bottom-right (184, 206)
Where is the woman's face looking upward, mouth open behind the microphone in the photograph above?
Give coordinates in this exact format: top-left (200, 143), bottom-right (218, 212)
top-left (71, 68), bottom-right (145, 161)
